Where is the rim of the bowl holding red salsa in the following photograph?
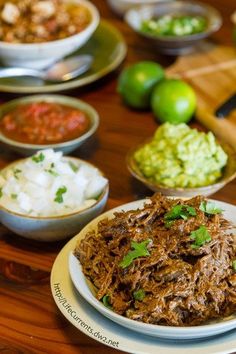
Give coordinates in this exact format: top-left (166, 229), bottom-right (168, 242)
top-left (0, 94), bottom-right (100, 150)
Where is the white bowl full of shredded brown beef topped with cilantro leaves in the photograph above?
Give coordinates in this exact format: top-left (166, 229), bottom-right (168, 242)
top-left (69, 194), bottom-right (236, 339)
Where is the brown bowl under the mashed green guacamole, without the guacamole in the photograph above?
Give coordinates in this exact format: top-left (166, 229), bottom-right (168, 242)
top-left (126, 137), bottom-right (236, 195)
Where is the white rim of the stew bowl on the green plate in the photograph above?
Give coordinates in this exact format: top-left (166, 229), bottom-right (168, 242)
top-left (0, 0), bottom-right (100, 50)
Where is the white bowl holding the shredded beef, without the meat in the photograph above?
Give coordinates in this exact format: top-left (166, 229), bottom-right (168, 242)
top-left (69, 200), bottom-right (236, 340)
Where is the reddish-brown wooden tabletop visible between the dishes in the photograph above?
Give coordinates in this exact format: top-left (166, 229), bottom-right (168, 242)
top-left (0, 0), bottom-right (236, 354)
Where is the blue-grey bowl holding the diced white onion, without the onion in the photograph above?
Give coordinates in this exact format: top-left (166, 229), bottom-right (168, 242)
top-left (0, 157), bottom-right (109, 242)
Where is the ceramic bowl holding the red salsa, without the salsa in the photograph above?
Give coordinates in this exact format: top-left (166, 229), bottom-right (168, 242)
top-left (0, 95), bottom-right (99, 156)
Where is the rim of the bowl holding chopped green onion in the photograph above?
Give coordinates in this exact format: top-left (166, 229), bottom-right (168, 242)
top-left (124, 0), bottom-right (223, 43)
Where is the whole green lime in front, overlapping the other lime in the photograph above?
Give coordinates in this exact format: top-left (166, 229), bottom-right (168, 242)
top-left (151, 79), bottom-right (197, 124)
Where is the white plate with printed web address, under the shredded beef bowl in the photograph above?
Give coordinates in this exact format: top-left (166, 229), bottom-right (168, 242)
top-left (51, 202), bottom-right (236, 354)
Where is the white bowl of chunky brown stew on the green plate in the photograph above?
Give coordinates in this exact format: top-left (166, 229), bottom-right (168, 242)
top-left (0, 0), bottom-right (99, 69)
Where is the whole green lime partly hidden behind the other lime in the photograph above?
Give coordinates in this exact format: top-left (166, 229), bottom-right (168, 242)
top-left (118, 61), bottom-right (164, 108)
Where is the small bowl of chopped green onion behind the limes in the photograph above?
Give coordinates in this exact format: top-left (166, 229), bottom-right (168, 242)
top-left (125, 1), bottom-right (222, 55)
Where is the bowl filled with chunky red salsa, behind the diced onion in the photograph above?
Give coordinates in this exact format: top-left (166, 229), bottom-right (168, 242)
top-left (0, 95), bottom-right (99, 156)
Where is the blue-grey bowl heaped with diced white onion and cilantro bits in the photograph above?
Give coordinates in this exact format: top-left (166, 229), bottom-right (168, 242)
top-left (0, 149), bottom-right (109, 241)
